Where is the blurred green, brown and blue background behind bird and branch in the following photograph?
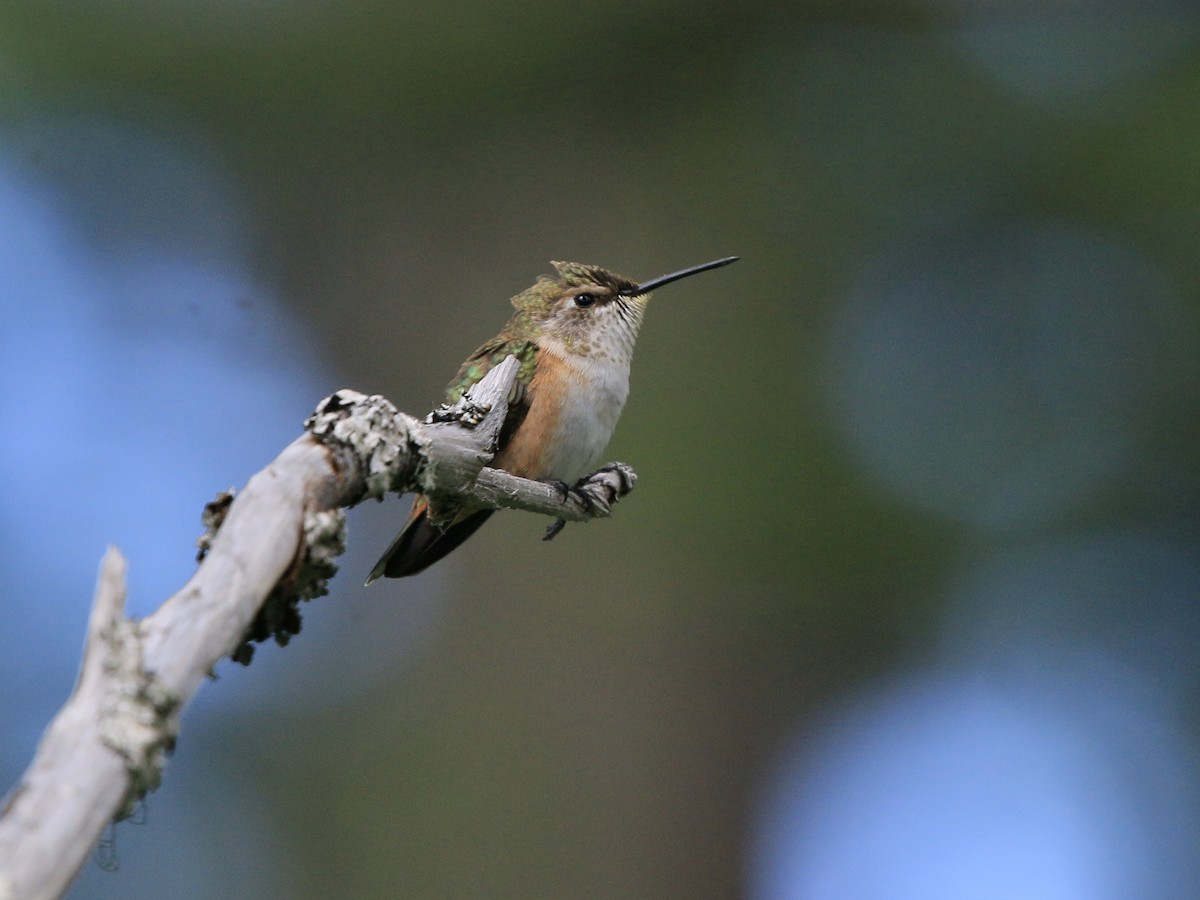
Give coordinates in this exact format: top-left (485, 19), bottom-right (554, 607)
top-left (0, 0), bottom-right (1200, 900)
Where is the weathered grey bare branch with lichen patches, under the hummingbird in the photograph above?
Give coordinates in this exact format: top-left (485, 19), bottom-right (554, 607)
top-left (0, 358), bottom-right (635, 900)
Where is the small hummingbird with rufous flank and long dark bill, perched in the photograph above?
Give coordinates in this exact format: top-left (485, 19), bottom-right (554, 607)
top-left (366, 257), bottom-right (738, 584)
